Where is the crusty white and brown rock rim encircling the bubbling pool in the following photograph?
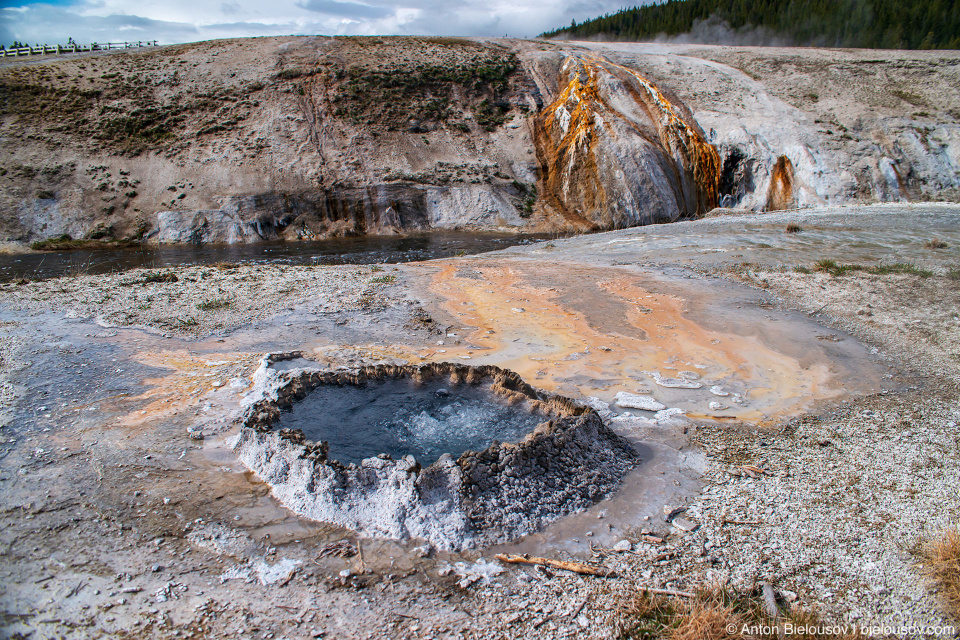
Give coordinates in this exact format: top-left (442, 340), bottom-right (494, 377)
top-left (235, 363), bottom-right (639, 549)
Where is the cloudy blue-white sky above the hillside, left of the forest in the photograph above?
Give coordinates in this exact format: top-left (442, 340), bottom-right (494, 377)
top-left (0, 0), bottom-right (633, 45)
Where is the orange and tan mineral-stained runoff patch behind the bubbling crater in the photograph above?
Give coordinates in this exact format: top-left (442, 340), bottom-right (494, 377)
top-left (419, 259), bottom-right (864, 424)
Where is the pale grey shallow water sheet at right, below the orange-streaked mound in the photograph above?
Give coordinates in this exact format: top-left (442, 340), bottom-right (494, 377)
top-left (525, 203), bottom-right (960, 268)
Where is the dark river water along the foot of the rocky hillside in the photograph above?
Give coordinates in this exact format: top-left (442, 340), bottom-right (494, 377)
top-left (0, 232), bottom-right (546, 280)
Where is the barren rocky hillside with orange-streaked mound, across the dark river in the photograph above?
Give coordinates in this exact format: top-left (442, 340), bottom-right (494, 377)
top-left (0, 37), bottom-right (960, 248)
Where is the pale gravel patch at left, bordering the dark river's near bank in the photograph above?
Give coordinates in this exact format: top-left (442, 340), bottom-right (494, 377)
top-left (0, 265), bottom-right (394, 337)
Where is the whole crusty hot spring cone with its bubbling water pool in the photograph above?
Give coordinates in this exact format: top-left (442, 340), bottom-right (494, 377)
top-left (235, 356), bottom-right (639, 549)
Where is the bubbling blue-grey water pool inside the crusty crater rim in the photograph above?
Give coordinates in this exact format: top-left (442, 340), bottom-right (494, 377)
top-left (279, 380), bottom-right (547, 465)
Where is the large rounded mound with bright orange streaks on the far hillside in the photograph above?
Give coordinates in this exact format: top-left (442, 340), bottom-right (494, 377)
top-left (534, 56), bottom-right (721, 229)
